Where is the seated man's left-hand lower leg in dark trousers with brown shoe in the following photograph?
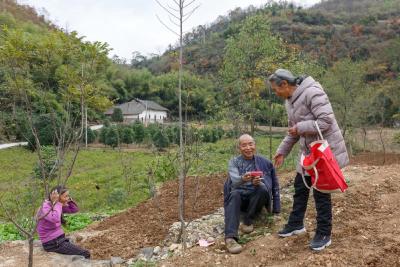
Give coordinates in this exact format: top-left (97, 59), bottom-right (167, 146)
top-left (224, 190), bottom-right (242, 254)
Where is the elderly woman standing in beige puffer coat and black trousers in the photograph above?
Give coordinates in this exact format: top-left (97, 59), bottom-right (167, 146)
top-left (268, 69), bottom-right (349, 251)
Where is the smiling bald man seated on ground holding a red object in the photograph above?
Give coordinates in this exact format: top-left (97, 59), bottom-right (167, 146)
top-left (224, 134), bottom-right (280, 254)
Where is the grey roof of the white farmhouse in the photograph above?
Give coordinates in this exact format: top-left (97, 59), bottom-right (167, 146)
top-left (104, 99), bottom-right (168, 115)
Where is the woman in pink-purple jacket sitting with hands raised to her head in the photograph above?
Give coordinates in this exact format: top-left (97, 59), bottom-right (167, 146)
top-left (37, 186), bottom-right (90, 258)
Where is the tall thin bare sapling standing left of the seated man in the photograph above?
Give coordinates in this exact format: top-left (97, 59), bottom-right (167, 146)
top-left (155, 0), bottom-right (200, 249)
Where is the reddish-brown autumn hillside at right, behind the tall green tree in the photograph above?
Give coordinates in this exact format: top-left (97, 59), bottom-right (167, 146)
top-left (131, 0), bottom-right (400, 128)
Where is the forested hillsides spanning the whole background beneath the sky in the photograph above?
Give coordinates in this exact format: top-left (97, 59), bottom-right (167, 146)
top-left (0, 0), bottom-right (400, 144)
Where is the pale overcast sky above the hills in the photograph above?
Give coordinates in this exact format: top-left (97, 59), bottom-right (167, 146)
top-left (18, 0), bottom-right (320, 60)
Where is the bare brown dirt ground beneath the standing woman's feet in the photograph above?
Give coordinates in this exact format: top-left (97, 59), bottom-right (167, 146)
top-left (160, 164), bottom-right (400, 266)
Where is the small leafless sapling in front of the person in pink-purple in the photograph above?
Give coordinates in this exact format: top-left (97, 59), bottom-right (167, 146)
top-left (0, 78), bottom-right (83, 267)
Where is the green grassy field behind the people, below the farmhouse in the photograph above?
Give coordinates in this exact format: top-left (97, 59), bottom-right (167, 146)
top-left (0, 136), bottom-right (296, 240)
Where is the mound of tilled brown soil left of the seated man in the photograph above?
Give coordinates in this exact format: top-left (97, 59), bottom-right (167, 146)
top-left (80, 174), bottom-right (226, 259)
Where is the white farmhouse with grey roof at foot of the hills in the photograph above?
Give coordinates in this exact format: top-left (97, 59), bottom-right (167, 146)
top-left (104, 99), bottom-right (168, 125)
